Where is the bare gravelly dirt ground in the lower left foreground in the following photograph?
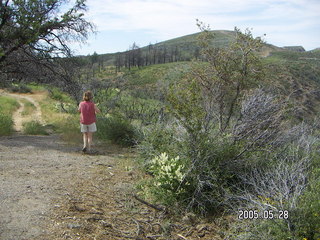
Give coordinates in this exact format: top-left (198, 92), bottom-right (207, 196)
top-left (0, 136), bottom-right (119, 240)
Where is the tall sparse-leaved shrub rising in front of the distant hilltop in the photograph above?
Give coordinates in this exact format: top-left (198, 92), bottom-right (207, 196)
top-left (193, 22), bottom-right (264, 132)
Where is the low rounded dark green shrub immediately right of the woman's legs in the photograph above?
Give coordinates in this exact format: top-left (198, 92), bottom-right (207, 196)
top-left (97, 117), bottom-right (138, 146)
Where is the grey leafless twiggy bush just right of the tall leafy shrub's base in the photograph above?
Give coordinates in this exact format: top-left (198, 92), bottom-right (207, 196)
top-left (232, 89), bottom-right (286, 158)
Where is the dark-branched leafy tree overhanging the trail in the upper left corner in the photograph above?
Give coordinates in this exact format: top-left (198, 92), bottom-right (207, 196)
top-left (0, 0), bottom-right (94, 85)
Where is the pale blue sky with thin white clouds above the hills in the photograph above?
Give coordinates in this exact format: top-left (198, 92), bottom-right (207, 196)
top-left (72, 0), bottom-right (320, 55)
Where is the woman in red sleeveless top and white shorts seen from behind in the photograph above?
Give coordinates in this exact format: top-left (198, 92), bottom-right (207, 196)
top-left (78, 91), bottom-right (100, 153)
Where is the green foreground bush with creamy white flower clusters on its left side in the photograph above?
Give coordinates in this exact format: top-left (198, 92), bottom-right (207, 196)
top-left (138, 121), bottom-right (239, 213)
